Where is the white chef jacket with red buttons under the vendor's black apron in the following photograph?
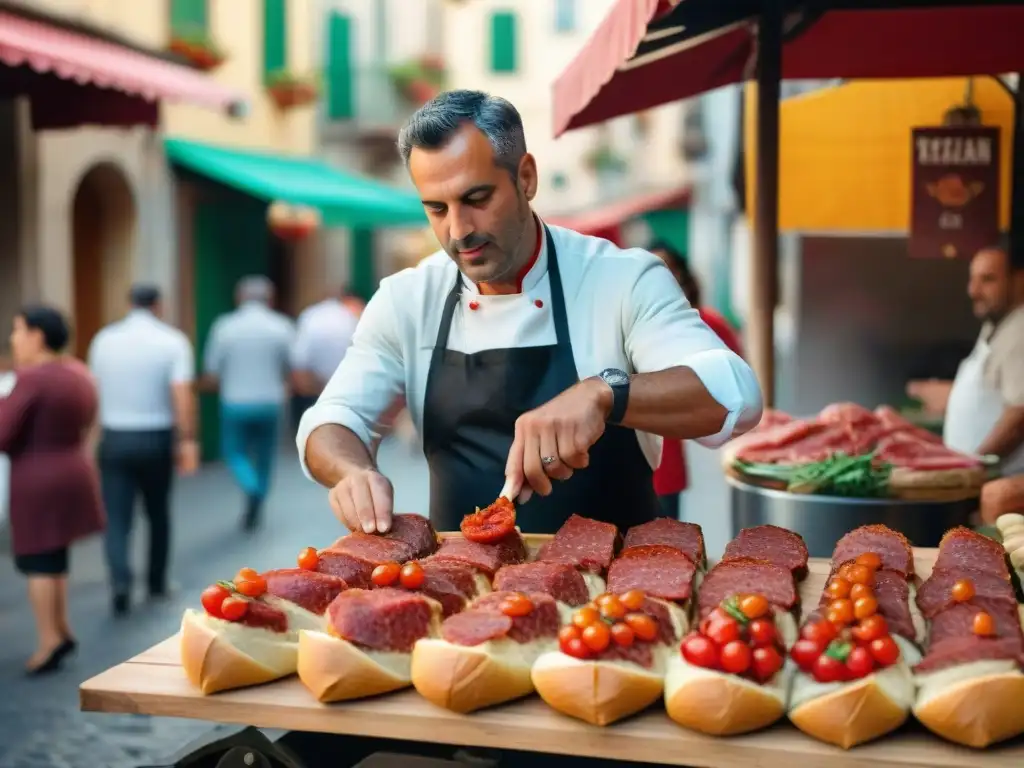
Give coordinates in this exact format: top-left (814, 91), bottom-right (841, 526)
top-left (296, 225), bottom-right (762, 476)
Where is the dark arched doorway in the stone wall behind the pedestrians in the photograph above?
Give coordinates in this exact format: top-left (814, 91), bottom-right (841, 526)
top-left (72, 163), bottom-right (136, 357)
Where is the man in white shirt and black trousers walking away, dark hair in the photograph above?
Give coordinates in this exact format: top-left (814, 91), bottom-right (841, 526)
top-left (89, 285), bottom-right (199, 615)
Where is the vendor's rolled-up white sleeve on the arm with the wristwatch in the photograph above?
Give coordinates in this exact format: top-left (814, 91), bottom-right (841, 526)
top-left (624, 254), bottom-right (763, 447)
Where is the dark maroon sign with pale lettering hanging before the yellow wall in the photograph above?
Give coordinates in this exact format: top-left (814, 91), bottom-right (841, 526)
top-left (909, 126), bottom-right (999, 259)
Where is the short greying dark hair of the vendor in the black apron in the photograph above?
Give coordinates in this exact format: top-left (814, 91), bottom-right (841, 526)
top-left (398, 90), bottom-right (526, 177)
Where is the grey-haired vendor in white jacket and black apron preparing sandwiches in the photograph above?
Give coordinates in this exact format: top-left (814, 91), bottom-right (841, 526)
top-left (297, 91), bottom-right (762, 534)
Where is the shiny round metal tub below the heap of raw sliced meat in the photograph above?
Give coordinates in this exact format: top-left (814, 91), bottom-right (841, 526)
top-left (726, 476), bottom-right (978, 557)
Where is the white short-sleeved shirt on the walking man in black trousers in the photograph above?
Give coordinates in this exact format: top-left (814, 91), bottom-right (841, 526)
top-left (88, 309), bottom-right (196, 431)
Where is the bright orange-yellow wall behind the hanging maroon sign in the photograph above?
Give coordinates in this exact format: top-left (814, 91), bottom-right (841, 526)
top-left (744, 77), bottom-right (1013, 231)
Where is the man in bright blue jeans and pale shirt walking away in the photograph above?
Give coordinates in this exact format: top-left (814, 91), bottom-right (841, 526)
top-left (204, 275), bottom-right (294, 530)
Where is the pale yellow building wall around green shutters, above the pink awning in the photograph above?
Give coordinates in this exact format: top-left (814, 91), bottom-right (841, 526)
top-left (26, 0), bottom-right (315, 155)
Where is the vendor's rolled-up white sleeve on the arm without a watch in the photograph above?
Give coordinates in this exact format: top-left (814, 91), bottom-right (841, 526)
top-left (296, 281), bottom-right (406, 477)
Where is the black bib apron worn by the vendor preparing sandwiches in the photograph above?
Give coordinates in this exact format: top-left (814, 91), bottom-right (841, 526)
top-left (423, 227), bottom-right (659, 534)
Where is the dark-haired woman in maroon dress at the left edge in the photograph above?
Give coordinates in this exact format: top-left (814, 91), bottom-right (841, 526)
top-left (0, 306), bottom-right (103, 674)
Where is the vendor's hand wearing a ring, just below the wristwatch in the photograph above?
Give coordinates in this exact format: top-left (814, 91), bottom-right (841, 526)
top-left (505, 379), bottom-right (611, 502)
